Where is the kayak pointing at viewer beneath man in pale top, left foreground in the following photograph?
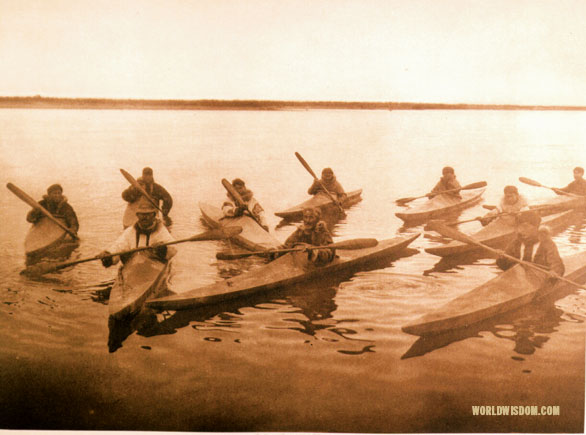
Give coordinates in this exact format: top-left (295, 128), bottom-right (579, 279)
top-left (108, 251), bottom-right (170, 320)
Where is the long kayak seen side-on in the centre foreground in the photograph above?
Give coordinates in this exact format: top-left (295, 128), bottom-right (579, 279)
top-left (146, 234), bottom-right (419, 310)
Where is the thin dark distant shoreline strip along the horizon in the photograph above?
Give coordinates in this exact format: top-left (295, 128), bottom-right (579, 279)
top-left (0, 96), bottom-right (586, 111)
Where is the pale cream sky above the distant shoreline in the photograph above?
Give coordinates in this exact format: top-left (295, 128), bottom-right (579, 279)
top-left (0, 0), bottom-right (586, 106)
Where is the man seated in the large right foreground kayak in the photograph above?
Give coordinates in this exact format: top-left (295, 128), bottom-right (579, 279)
top-left (496, 211), bottom-right (565, 276)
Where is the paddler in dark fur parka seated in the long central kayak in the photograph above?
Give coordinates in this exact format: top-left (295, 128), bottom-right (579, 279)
top-left (285, 208), bottom-right (335, 266)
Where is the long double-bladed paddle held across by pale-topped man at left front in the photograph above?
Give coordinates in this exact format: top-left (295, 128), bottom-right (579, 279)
top-left (20, 227), bottom-right (242, 276)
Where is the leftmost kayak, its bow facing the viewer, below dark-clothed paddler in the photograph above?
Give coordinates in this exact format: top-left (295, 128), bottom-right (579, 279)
top-left (24, 217), bottom-right (79, 259)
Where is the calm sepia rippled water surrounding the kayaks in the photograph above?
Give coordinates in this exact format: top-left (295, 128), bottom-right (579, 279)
top-left (0, 110), bottom-right (586, 432)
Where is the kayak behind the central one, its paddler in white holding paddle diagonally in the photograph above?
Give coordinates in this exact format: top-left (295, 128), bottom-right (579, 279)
top-left (199, 202), bottom-right (281, 251)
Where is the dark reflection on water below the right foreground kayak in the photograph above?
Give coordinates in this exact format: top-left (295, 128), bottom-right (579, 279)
top-left (401, 289), bottom-right (583, 359)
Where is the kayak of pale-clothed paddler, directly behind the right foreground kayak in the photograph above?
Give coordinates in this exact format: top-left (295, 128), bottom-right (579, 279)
top-left (425, 210), bottom-right (576, 257)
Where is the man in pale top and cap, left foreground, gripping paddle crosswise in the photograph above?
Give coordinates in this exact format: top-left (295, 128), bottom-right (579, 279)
top-left (99, 198), bottom-right (177, 267)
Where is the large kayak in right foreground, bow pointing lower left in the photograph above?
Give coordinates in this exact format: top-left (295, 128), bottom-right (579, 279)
top-left (402, 252), bottom-right (586, 336)
